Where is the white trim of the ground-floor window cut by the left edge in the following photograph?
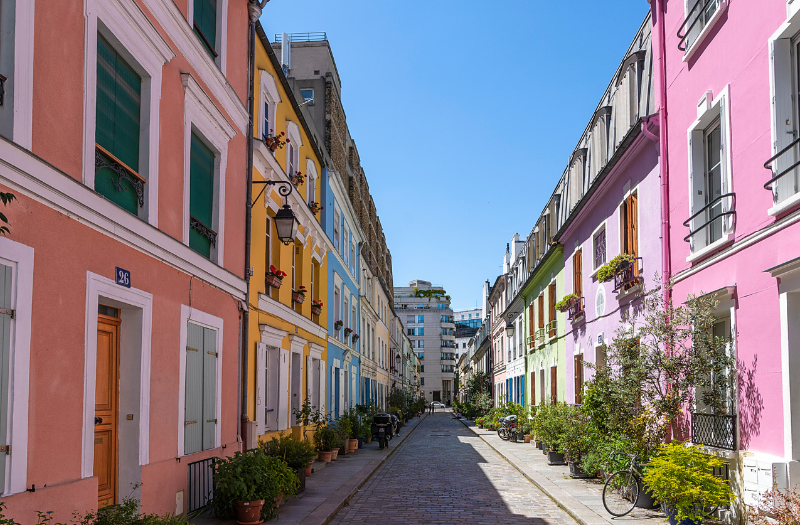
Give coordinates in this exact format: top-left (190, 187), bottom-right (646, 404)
top-left (0, 237), bottom-right (33, 496)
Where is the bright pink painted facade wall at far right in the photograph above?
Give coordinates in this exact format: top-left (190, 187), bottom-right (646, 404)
top-left (664, 0), bottom-right (800, 456)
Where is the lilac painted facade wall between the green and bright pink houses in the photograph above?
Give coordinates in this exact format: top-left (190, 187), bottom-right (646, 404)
top-left (560, 135), bottom-right (661, 403)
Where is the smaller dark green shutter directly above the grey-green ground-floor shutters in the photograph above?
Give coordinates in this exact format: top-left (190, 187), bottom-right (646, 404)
top-left (189, 133), bottom-right (214, 258)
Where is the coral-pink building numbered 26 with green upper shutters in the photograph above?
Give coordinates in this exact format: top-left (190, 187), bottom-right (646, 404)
top-left (0, 0), bottom-right (248, 523)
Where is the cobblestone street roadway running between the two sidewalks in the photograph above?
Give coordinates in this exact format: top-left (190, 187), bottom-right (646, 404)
top-left (331, 412), bottom-right (575, 525)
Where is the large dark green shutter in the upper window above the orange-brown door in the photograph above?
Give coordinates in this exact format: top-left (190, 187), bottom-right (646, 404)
top-left (95, 35), bottom-right (142, 214)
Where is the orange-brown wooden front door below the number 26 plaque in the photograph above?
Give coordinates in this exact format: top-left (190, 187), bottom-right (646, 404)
top-left (94, 305), bottom-right (120, 507)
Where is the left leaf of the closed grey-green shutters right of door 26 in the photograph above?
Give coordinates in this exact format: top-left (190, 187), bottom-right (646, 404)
top-left (183, 323), bottom-right (205, 454)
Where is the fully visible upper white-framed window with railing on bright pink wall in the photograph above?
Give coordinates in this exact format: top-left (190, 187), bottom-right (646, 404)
top-left (684, 88), bottom-right (735, 254)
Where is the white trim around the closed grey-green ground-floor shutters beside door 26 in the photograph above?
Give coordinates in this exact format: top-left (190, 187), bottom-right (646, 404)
top-left (178, 304), bottom-right (223, 457)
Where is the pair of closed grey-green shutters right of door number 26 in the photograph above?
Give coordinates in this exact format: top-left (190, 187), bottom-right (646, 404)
top-left (183, 323), bottom-right (218, 454)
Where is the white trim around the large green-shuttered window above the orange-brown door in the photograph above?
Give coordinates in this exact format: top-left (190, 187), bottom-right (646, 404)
top-left (83, 0), bottom-right (175, 226)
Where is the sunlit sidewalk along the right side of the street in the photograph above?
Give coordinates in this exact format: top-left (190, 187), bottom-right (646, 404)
top-left (461, 419), bottom-right (665, 525)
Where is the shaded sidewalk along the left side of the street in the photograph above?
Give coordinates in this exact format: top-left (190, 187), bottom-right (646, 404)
top-left (191, 415), bottom-right (426, 525)
